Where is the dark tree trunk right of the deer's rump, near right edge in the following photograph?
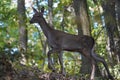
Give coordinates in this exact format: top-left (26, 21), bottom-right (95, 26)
top-left (103, 0), bottom-right (118, 66)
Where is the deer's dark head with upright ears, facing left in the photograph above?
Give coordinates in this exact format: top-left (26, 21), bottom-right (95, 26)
top-left (30, 7), bottom-right (44, 24)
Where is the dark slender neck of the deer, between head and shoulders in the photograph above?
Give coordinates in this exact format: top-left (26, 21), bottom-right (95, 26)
top-left (39, 18), bottom-right (54, 38)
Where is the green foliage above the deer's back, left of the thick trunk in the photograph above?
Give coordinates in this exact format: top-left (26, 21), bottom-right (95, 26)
top-left (53, 0), bottom-right (77, 34)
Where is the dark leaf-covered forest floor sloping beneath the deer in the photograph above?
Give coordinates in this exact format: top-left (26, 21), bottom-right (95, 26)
top-left (0, 55), bottom-right (85, 80)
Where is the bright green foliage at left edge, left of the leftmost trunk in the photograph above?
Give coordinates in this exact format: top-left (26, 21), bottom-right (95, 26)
top-left (0, 0), bottom-right (18, 47)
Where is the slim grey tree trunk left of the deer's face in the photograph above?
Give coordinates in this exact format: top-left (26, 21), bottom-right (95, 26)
top-left (17, 0), bottom-right (27, 63)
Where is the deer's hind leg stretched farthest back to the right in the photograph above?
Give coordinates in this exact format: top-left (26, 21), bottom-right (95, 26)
top-left (92, 52), bottom-right (114, 80)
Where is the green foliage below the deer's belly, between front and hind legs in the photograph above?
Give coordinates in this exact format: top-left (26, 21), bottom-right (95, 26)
top-left (64, 52), bottom-right (81, 75)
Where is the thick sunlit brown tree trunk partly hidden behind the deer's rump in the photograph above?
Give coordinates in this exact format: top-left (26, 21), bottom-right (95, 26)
top-left (74, 0), bottom-right (91, 74)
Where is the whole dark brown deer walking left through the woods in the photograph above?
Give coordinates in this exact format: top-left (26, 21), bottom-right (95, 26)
top-left (30, 7), bottom-right (114, 80)
